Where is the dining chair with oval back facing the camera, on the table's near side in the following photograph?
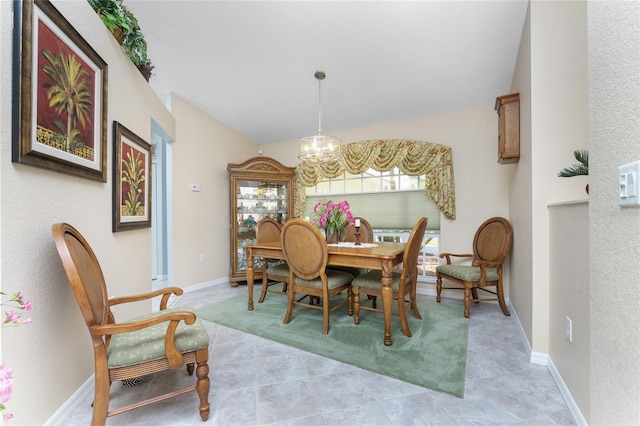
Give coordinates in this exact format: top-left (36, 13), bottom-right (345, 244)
top-left (281, 219), bottom-right (353, 334)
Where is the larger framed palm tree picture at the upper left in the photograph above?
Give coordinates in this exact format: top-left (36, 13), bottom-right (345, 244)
top-left (11, 0), bottom-right (108, 182)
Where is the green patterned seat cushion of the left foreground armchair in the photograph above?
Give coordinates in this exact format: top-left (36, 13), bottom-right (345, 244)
top-left (107, 308), bottom-right (209, 368)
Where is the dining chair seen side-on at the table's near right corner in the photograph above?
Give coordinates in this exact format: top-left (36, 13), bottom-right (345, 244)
top-left (352, 217), bottom-right (427, 337)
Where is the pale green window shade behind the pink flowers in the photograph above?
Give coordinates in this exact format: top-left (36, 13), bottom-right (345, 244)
top-left (302, 190), bottom-right (440, 230)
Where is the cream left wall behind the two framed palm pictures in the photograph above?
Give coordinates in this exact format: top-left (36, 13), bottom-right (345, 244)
top-left (0, 1), bottom-right (174, 425)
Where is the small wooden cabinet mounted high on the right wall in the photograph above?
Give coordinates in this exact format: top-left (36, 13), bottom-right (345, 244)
top-left (495, 93), bottom-right (520, 164)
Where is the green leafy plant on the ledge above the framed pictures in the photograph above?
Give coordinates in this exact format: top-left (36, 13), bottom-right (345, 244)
top-left (87, 0), bottom-right (155, 81)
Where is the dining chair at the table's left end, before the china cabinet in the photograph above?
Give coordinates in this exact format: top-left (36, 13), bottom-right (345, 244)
top-left (256, 217), bottom-right (289, 303)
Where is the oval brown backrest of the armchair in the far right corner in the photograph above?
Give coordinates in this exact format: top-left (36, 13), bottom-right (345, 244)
top-left (473, 217), bottom-right (513, 264)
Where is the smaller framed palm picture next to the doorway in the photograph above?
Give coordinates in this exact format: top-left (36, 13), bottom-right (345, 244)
top-left (112, 121), bottom-right (153, 232)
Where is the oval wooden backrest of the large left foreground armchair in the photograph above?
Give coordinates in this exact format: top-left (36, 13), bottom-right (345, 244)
top-left (51, 223), bottom-right (113, 332)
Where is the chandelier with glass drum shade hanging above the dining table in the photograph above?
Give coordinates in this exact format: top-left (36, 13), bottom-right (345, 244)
top-left (298, 71), bottom-right (342, 162)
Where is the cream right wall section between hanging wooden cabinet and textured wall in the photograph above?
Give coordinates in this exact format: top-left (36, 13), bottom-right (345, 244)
top-left (510, 1), bottom-right (589, 353)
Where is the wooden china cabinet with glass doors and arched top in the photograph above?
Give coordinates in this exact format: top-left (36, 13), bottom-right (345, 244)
top-left (227, 157), bottom-right (294, 287)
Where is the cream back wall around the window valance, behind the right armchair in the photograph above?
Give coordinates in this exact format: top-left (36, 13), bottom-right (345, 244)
top-left (261, 105), bottom-right (510, 294)
